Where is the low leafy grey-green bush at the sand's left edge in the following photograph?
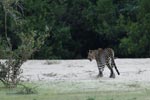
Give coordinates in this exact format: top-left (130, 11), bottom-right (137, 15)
top-left (0, 32), bottom-right (46, 87)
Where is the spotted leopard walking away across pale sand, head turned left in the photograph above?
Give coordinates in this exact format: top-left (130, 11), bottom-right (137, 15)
top-left (88, 48), bottom-right (120, 78)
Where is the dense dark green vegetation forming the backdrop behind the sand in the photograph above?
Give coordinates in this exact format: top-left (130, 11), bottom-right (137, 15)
top-left (0, 0), bottom-right (150, 59)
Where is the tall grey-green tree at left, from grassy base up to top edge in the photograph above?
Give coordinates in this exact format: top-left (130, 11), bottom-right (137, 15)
top-left (0, 0), bottom-right (49, 87)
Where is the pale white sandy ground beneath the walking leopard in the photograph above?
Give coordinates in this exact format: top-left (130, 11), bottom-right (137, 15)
top-left (21, 58), bottom-right (150, 92)
